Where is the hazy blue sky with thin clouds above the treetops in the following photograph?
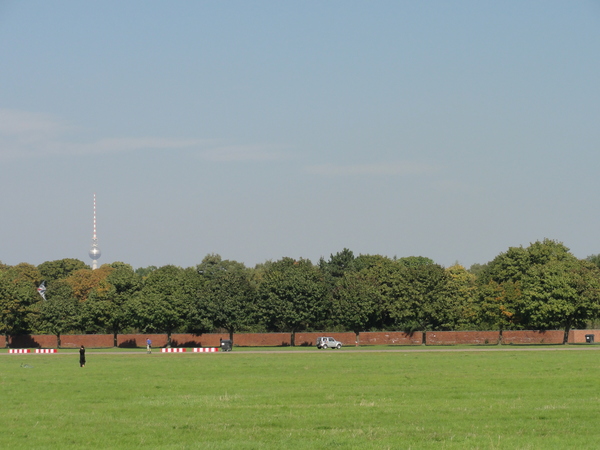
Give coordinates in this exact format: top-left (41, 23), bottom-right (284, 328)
top-left (0, 0), bottom-right (600, 267)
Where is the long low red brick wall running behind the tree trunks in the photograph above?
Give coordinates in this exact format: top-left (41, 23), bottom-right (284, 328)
top-left (0, 330), bottom-right (600, 348)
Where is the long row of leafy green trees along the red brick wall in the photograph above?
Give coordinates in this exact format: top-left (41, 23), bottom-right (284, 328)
top-left (0, 239), bottom-right (600, 345)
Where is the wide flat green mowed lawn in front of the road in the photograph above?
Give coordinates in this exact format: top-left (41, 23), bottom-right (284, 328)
top-left (0, 348), bottom-right (600, 449)
